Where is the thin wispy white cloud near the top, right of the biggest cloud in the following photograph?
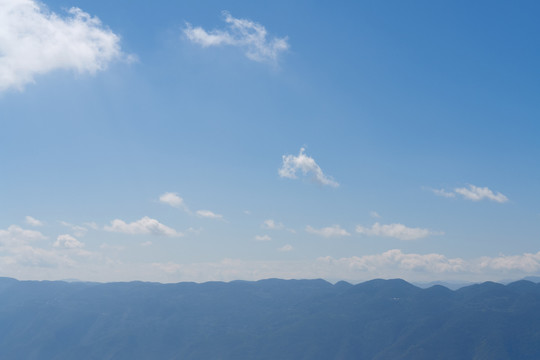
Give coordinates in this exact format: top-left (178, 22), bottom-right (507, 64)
top-left (184, 11), bottom-right (289, 63)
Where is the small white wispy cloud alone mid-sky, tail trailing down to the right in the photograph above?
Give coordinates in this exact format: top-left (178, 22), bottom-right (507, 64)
top-left (278, 148), bottom-right (339, 187)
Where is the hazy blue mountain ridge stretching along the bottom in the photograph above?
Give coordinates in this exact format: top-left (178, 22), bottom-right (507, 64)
top-left (0, 278), bottom-right (540, 360)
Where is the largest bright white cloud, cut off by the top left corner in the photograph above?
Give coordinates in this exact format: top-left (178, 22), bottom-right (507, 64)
top-left (0, 0), bottom-right (129, 91)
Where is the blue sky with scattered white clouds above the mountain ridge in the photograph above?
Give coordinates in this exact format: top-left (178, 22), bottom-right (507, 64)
top-left (0, 0), bottom-right (540, 282)
